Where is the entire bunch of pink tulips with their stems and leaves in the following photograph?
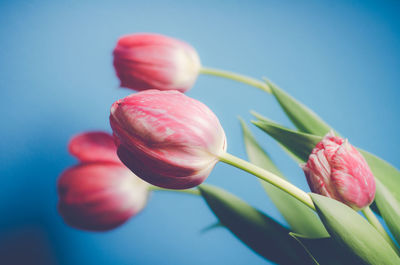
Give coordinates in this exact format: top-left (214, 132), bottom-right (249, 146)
top-left (57, 34), bottom-right (400, 265)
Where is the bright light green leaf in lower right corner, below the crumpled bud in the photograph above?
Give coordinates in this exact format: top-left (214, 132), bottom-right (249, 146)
top-left (310, 193), bottom-right (400, 265)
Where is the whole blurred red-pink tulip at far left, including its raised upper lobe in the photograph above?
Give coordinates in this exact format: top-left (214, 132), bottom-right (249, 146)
top-left (57, 132), bottom-right (149, 231)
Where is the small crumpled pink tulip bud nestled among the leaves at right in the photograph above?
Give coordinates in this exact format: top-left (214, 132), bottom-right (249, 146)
top-left (302, 132), bottom-right (375, 210)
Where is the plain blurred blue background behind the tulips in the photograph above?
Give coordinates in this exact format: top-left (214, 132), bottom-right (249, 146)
top-left (0, 0), bottom-right (400, 265)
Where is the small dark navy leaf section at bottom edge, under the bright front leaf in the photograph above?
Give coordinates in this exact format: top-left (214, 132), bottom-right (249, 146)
top-left (290, 233), bottom-right (364, 265)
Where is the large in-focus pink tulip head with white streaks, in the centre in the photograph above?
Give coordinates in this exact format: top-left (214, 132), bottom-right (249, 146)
top-left (110, 90), bottom-right (226, 189)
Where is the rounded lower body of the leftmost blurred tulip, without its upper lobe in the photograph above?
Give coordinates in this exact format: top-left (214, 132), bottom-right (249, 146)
top-left (58, 162), bottom-right (148, 231)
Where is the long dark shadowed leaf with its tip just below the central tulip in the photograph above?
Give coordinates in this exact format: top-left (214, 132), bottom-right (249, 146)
top-left (198, 184), bottom-right (311, 265)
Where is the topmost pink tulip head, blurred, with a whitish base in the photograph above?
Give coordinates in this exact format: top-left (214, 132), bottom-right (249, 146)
top-left (113, 34), bottom-right (201, 92)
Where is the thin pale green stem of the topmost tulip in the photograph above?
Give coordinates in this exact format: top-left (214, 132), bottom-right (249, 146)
top-left (200, 67), bottom-right (271, 93)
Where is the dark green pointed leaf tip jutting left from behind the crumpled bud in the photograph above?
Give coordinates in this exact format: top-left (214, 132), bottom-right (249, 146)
top-left (252, 116), bottom-right (322, 163)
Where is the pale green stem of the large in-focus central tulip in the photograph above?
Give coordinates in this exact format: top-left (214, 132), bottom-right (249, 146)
top-left (219, 153), bottom-right (315, 211)
